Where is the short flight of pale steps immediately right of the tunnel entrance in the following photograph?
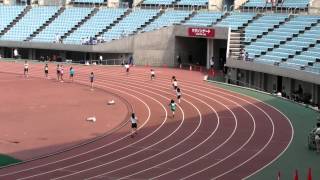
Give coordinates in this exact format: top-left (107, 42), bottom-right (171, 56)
top-left (229, 31), bottom-right (243, 58)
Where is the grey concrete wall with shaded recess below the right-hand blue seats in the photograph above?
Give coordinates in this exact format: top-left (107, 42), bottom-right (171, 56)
top-left (226, 60), bottom-right (320, 104)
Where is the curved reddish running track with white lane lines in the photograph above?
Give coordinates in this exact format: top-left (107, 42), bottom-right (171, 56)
top-left (0, 63), bottom-right (293, 180)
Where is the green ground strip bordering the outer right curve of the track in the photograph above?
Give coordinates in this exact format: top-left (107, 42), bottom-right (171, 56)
top-left (209, 83), bottom-right (320, 180)
